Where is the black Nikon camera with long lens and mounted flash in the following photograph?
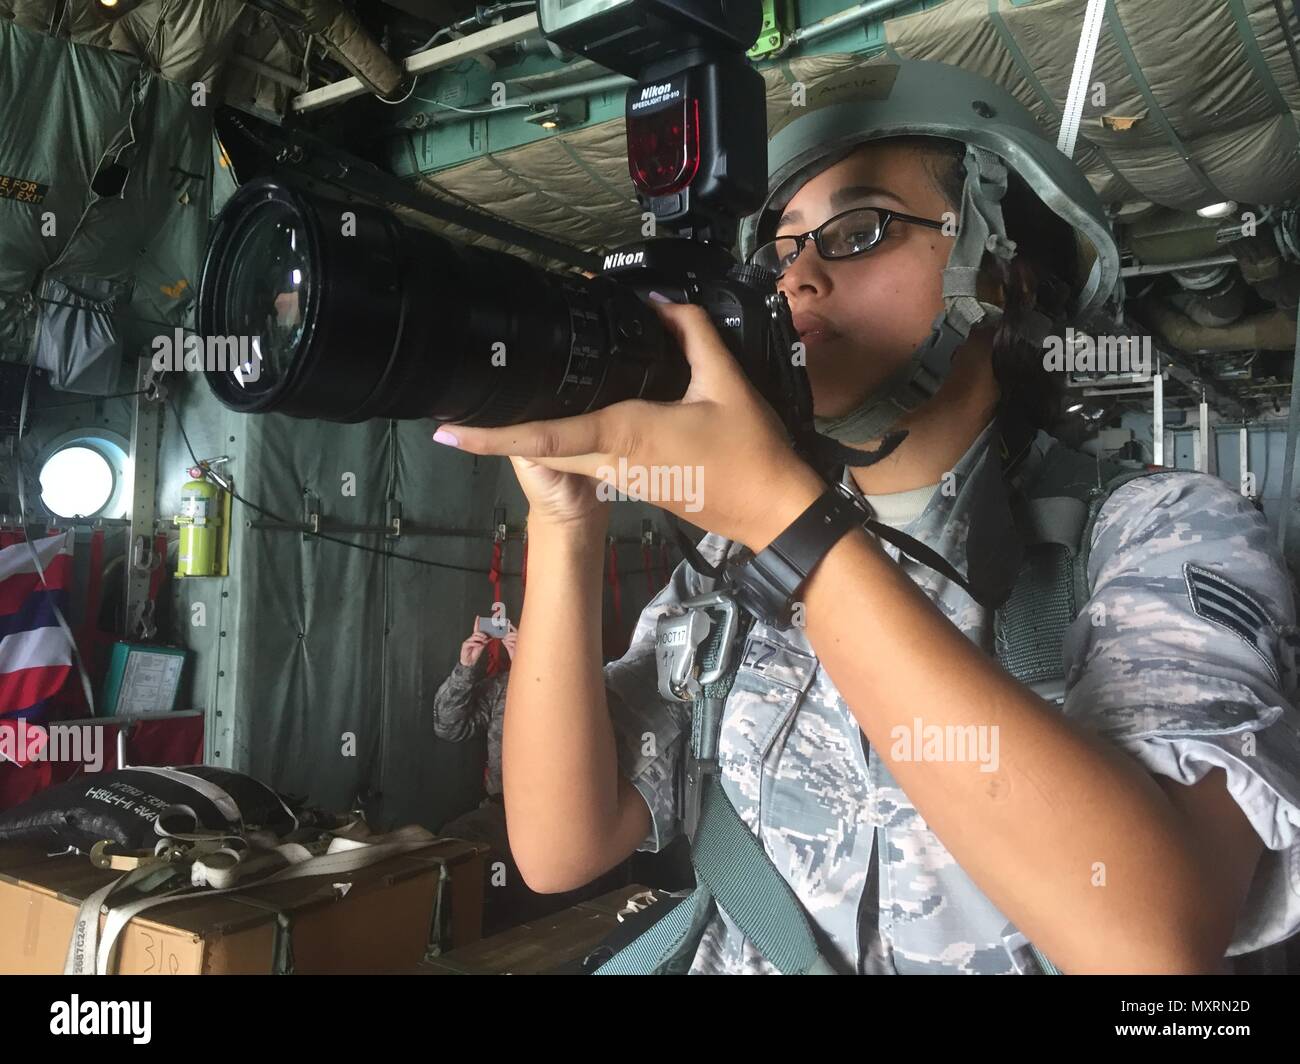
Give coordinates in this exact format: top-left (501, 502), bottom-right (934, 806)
top-left (198, 0), bottom-right (811, 436)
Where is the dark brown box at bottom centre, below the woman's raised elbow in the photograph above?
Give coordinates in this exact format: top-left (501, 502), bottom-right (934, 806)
top-left (416, 884), bottom-right (646, 976)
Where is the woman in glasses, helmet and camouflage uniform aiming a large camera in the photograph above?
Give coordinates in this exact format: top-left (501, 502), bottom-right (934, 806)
top-left (436, 61), bottom-right (1300, 973)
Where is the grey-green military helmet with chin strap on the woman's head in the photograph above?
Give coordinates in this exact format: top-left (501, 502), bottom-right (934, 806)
top-left (740, 60), bottom-right (1119, 442)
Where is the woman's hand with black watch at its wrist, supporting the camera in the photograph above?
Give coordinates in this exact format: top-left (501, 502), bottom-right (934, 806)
top-left (434, 302), bottom-right (826, 552)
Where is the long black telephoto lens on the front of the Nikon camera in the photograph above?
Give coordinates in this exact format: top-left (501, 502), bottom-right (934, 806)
top-left (198, 178), bottom-right (690, 427)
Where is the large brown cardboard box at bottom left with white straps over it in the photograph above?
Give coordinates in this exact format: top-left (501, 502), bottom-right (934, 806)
top-left (0, 839), bottom-right (488, 976)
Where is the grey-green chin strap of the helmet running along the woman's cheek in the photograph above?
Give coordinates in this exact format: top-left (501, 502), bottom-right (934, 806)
top-left (814, 144), bottom-right (1015, 452)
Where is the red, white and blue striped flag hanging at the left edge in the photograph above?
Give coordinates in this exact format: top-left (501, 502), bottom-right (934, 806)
top-left (0, 529), bottom-right (73, 722)
